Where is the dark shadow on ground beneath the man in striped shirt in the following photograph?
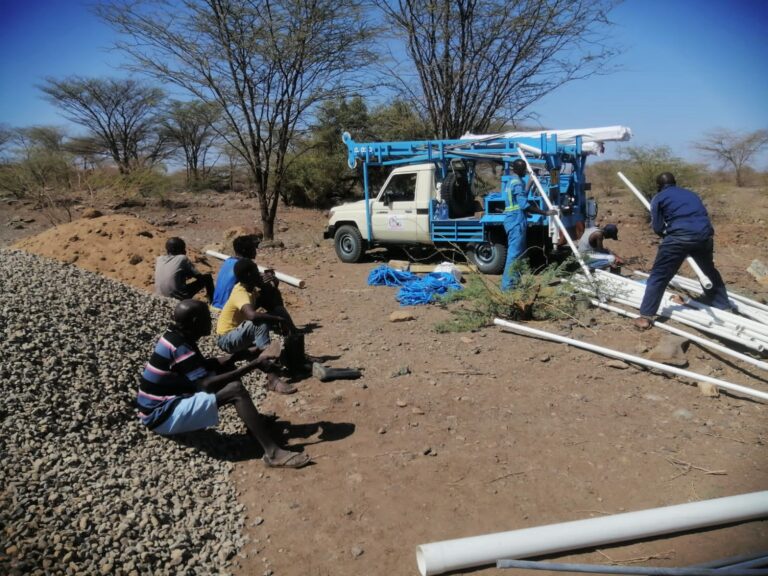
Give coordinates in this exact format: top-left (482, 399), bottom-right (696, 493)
top-left (168, 417), bottom-right (355, 462)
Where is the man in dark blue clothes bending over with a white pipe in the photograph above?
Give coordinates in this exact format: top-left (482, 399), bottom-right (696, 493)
top-left (634, 172), bottom-right (731, 330)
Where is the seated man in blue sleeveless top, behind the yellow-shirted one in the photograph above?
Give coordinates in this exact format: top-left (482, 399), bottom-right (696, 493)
top-left (212, 234), bottom-right (297, 332)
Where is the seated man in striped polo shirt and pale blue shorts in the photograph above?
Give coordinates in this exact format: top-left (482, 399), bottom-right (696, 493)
top-left (137, 300), bottom-right (310, 468)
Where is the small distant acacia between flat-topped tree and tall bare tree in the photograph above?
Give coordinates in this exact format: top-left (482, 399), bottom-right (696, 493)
top-left (161, 100), bottom-right (220, 184)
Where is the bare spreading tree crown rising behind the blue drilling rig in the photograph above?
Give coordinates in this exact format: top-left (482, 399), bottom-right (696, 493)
top-left (374, 0), bottom-right (616, 138)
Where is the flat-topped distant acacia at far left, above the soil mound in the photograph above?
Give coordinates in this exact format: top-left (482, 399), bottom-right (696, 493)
top-left (40, 76), bottom-right (165, 174)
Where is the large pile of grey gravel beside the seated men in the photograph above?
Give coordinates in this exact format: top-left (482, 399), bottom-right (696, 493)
top-left (0, 250), bottom-right (255, 575)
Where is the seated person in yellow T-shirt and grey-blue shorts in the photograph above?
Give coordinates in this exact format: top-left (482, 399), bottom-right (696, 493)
top-left (216, 258), bottom-right (296, 394)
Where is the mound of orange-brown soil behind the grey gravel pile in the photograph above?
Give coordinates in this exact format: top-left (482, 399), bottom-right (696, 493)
top-left (14, 215), bottom-right (213, 291)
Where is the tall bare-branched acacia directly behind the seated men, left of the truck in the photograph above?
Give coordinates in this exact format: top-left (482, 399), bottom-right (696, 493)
top-left (97, 0), bottom-right (369, 239)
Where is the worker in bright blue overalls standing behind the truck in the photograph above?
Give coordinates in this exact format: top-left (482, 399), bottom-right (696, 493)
top-left (501, 160), bottom-right (557, 291)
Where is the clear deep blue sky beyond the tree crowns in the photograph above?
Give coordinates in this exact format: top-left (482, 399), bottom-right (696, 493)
top-left (0, 0), bottom-right (768, 169)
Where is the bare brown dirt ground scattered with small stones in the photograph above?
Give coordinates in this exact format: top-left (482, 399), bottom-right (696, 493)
top-left (0, 184), bottom-right (768, 576)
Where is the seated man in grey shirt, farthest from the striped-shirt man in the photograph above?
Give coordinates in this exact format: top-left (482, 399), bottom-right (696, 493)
top-left (155, 237), bottom-right (213, 302)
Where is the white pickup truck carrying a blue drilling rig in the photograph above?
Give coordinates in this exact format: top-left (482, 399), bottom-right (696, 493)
top-left (324, 127), bottom-right (630, 274)
